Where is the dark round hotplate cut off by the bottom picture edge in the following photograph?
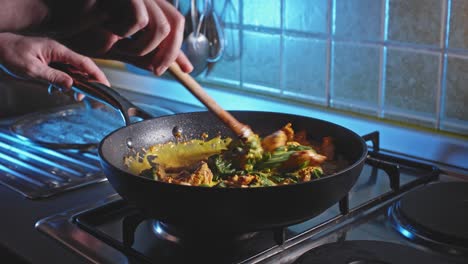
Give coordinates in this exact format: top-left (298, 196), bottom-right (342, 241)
top-left (294, 240), bottom-right (455, 264)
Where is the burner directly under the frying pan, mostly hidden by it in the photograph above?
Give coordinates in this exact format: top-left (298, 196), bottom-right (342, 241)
top-left (153, 220), bottom-right (258, 246)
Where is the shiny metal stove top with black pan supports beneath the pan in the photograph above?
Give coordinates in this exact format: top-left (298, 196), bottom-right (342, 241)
top-left (36, 132), bottom-right (468, 263)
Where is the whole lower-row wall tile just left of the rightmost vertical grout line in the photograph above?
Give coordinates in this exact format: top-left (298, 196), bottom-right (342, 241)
top-left (384, 49), bottom-right (440, 125)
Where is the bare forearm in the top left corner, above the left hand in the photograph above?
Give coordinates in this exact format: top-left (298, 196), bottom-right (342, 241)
top-left (0, 0), bottom-right (48, 32)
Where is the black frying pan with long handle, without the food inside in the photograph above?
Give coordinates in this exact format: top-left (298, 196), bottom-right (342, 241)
top-left (67, 68), bottom-right (367, 233)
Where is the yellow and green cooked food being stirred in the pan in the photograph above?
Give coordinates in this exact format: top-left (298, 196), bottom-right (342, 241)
top-left (124, 123), bottom-right (346, 187)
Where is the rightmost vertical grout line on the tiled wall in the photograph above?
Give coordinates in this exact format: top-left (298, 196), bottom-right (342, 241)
top-left (435, 0), bottom-right (452, 130)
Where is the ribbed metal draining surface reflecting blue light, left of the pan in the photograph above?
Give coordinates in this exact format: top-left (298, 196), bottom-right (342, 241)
top-left (0, 126), bottom-right (107, 199)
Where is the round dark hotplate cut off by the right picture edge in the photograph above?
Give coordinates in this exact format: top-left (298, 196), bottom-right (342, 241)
top-left (389, 182), bottom-right (468, 255)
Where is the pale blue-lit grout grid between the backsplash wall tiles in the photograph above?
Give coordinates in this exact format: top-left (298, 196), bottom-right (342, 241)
top-left (223, 0), bottom-right (458, 134)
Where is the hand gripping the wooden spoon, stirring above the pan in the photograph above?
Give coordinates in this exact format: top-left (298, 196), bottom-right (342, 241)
top-left (54, 0), bottom-right (193, 75)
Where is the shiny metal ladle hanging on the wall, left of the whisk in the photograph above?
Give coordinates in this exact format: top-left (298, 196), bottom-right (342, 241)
top-left (182, 0), bottom-right (210, 76)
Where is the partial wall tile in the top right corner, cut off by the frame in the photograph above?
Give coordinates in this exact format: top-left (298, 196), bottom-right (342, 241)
top-left (449, 0), bottom-right (468, 49)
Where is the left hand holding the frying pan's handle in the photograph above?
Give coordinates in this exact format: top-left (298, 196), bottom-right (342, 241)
top-left (0, 33), bottom-right (110, 89)
